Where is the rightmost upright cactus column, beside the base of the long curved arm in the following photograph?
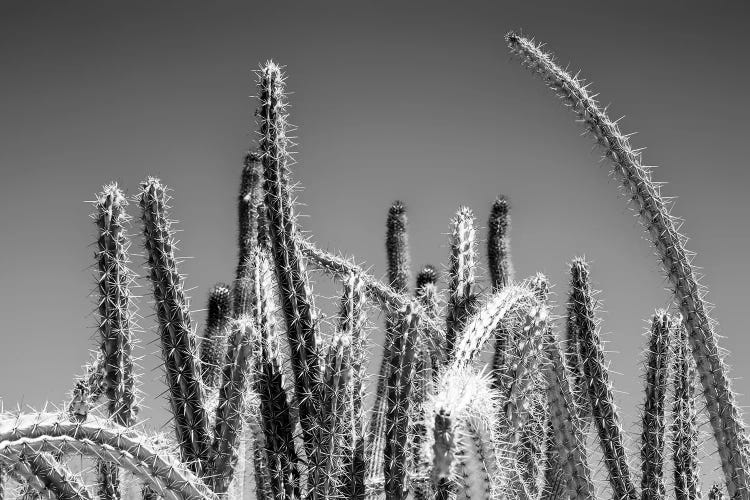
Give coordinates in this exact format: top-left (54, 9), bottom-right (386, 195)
top-left (671, 326), bottom-right (701, 500)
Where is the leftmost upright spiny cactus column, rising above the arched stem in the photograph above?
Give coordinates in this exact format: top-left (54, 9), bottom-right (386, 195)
top-left (92, 184), bottom-right (135, 425)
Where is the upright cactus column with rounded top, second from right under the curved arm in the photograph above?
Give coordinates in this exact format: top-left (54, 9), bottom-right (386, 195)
top-left (641, 311), bottom-right (672, 500)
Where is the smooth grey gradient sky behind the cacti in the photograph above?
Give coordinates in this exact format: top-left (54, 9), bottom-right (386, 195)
top-left (0, 1), bottom-right (750, 488)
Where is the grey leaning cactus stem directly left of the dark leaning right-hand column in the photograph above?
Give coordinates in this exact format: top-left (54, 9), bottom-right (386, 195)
top-left (544, 329), bottom-right (595, 500)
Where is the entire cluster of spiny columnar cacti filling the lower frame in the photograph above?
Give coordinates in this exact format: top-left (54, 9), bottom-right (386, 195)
top-left (0, 33), bottom-right (750, 500)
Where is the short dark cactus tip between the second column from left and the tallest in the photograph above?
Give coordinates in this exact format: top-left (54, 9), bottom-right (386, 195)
top-left (200, 283), bottom-right (232, 389)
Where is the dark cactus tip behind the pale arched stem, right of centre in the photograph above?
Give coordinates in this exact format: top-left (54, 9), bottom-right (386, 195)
top-left (487, 196), bottom-right (513, 291)
